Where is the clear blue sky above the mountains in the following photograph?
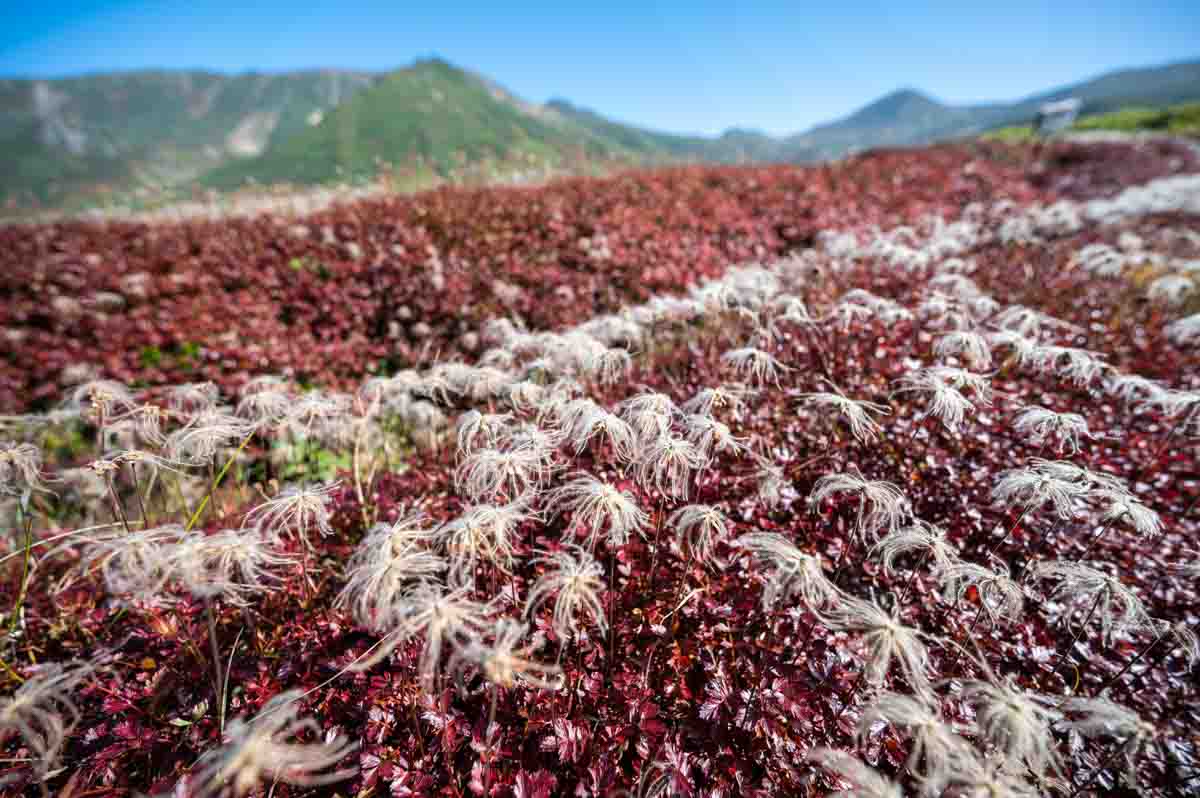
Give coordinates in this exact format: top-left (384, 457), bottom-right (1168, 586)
top-left (0, 0), bottom-right (1200, 133)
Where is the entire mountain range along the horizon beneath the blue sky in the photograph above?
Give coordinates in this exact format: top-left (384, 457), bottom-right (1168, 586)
top-left (0, 58), bottom-right (1200, 208)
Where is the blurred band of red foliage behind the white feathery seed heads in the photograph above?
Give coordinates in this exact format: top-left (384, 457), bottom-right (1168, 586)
top-left (0, 146), bottom-right (1046, 412)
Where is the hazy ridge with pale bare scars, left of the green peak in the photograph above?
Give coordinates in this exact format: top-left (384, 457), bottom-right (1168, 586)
top-left (0, 71), bottom-right (374, 203)
